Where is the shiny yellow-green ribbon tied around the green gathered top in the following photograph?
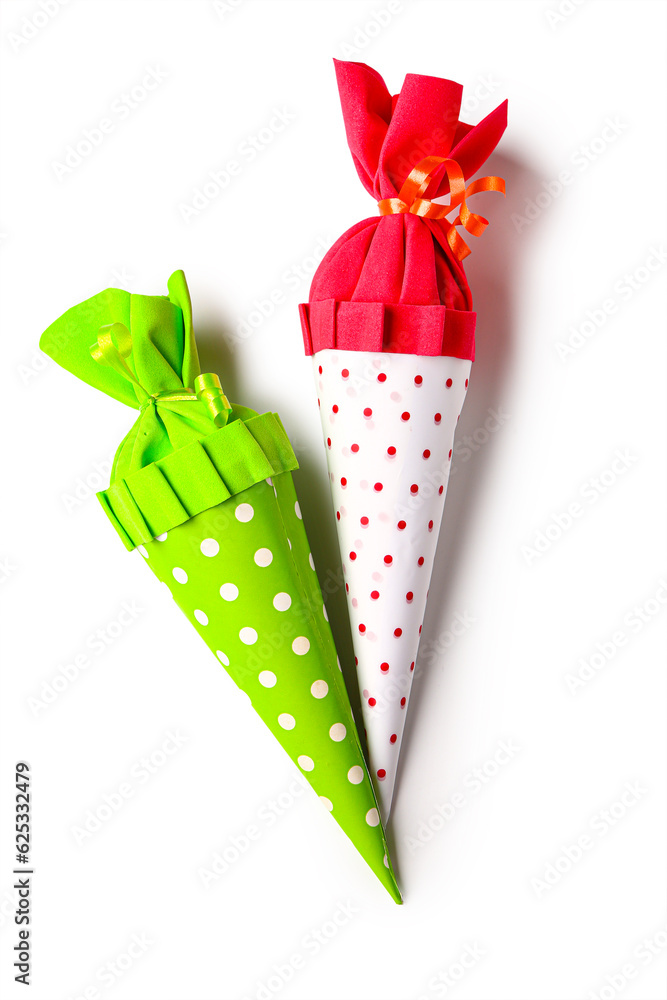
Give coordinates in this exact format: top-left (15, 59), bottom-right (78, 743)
top-left (90, 323), bottom-right (232, 427)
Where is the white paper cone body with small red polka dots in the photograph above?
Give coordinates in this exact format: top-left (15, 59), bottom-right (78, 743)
top-left (313, 350), bottom-right (471, 819)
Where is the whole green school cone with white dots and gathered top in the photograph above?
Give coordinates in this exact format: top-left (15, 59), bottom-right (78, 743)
top-left (40, 271), bottom-right (401, 903)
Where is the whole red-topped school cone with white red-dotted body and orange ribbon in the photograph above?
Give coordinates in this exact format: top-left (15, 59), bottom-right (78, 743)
top-left (300, 61), bottom-right (507, 820)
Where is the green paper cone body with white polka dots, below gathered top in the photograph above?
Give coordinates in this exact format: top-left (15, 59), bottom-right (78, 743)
top-left (142, 473), bottom-right (401, 902)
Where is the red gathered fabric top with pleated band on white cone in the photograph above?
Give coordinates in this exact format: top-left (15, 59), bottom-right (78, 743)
top-left (300, 60), bottom-right (507, 359)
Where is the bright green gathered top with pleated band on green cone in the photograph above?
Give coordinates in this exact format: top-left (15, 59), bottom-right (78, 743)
top-left (40, 271), bottom-right (298, 549)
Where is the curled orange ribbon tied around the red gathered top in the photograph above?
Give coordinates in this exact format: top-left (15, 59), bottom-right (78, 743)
top-left (378, 156), bottom-right (505, 260)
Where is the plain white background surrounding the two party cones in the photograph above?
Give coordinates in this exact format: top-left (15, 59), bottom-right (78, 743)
top-left (0, 0), bottom-right (667, 1000)
